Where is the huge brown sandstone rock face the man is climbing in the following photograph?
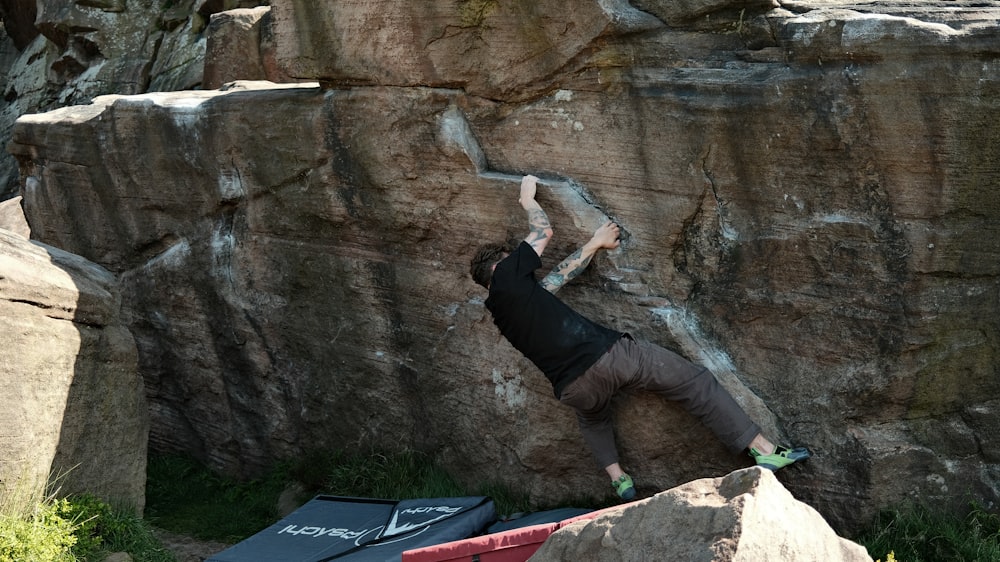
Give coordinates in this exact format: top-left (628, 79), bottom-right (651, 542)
top-left (10, 0), bottom-right (1000, 529)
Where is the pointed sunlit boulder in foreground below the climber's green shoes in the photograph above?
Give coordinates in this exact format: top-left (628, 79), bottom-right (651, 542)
top-left (530, 468), bottom-right (872, 562)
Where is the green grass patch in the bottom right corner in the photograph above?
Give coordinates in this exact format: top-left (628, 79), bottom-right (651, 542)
top-left (854, 503), bottom-right (1000, 562)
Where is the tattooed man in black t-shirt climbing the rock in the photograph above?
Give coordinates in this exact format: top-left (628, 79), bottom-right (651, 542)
top-left (470, 176), bottom-right (810, 500)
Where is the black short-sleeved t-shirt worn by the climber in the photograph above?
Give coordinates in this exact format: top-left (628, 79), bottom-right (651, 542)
top-left (486, 242), bottom-right (622, 398)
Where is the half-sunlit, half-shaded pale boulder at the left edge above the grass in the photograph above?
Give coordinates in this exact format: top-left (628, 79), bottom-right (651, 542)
top-left (0, 230), bottom-right (149, 513)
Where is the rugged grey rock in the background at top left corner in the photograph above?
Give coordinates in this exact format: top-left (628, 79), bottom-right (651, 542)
top-left (0, 0), bottom-right (267, 199)
